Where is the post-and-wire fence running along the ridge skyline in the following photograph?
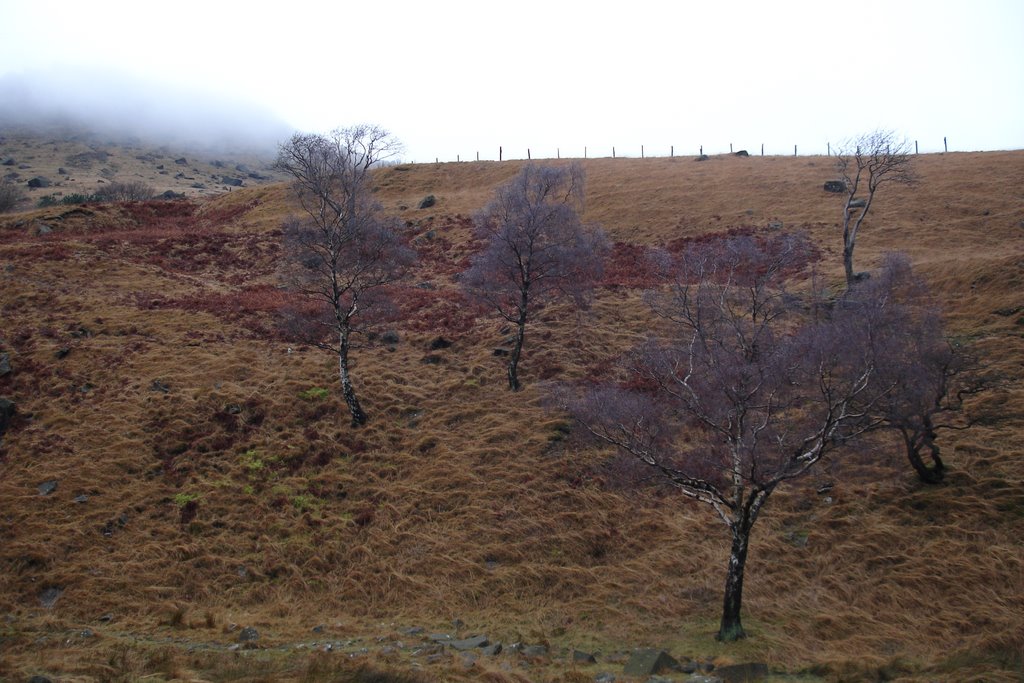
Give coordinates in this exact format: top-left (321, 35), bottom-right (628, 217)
top-left (412, 137), bottom-right (949, 164)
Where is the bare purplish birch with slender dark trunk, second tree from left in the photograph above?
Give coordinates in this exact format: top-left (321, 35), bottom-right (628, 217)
top-left (462, 164), bottom-right (608, 391)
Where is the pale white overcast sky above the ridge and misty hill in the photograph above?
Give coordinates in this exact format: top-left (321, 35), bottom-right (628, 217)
top-left (0, 0), bottom-right (1024, 161)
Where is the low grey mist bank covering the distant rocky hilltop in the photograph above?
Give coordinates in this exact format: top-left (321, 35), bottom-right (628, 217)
top-left (0, 69), bottom-right (292, 155)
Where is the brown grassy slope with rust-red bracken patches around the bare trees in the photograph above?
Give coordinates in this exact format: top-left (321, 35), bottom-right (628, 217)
top-left (0, 153), bottom-right (1024, 681)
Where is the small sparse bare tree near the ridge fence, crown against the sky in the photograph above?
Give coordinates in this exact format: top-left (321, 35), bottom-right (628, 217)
top-left (836, 130), bottom-right (914, 289)
